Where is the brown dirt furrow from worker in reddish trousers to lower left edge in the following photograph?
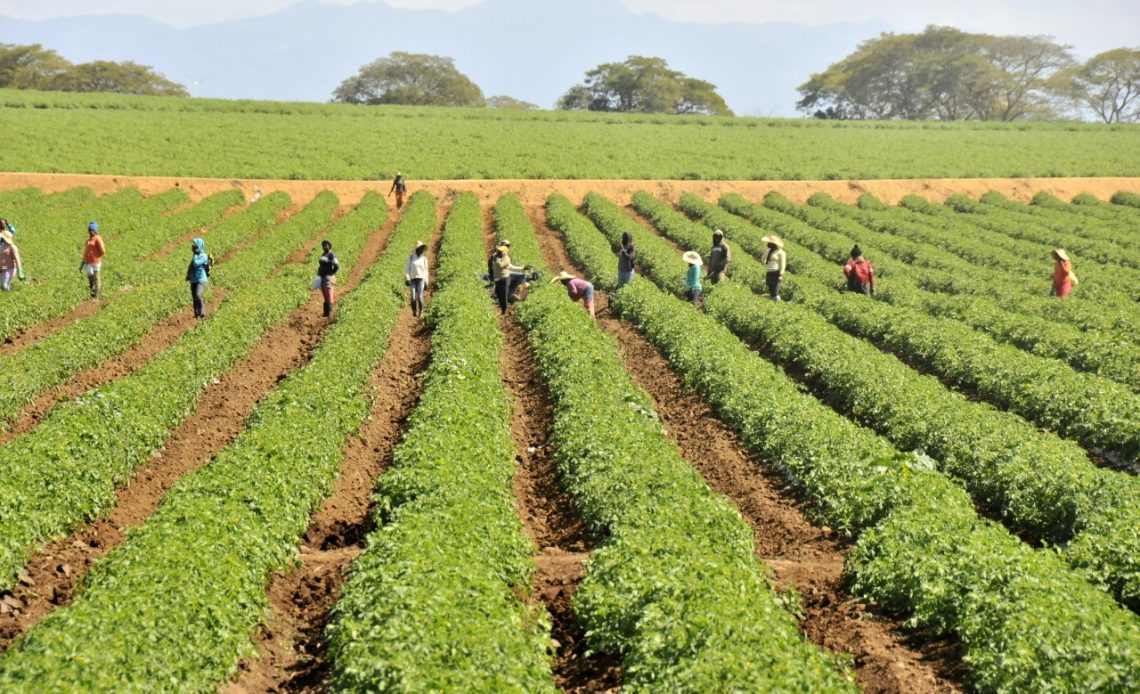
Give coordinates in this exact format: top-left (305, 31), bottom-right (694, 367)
top-left (0, 208), bottom-right (401, 651)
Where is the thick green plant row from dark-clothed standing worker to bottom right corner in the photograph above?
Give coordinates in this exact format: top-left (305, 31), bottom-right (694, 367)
top-left (559, 193), bottom-right (1140, 692)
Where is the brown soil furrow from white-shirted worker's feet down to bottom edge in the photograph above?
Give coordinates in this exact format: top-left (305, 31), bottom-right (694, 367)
top-left (225, 202), bottom-right (439, 694)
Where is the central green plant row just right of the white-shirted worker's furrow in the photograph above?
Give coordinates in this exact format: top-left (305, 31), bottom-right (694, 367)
top-left (328, 193), bottom-right (555, 692)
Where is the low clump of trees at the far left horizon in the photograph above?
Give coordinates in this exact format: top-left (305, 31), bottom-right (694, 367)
top-left (0, 43), bottom-right (189, 97)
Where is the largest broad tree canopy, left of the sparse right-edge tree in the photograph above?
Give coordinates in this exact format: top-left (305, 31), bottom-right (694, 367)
top-left (796, 26), bottom-right (1074, 121)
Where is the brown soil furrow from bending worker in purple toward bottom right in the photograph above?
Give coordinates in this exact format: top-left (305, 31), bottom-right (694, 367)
top-left (531, 210), bottom-right (966, 692)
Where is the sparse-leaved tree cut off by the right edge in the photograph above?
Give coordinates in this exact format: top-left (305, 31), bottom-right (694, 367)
top-left (1064, 48), bottom-right (1140, 123)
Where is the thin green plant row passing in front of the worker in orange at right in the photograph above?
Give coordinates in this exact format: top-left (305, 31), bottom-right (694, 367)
top-left (747, 191), bottom-right (1140, 332)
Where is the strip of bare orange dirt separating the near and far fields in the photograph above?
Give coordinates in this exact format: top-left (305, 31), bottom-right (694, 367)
top-left (0, 172), bottom-right (1140, 205)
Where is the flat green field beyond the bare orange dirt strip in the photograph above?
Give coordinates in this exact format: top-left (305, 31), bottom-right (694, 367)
top-left (0, 90), bottom-right (1140, 180)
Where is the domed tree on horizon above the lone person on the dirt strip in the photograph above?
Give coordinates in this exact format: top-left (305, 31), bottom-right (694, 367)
top-left (333, 51), bottom-right (483, 106)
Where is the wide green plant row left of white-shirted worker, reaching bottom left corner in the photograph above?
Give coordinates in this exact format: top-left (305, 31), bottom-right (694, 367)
top-left (0, 194), bottom-right (405, 692)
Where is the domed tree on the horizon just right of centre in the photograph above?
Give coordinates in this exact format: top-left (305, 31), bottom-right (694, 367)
top-left (555, 56), bottom-right (732, 115)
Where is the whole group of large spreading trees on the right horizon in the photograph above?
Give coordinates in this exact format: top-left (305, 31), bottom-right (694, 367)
top-left (796, 26), bottom-right (1140, 123)
